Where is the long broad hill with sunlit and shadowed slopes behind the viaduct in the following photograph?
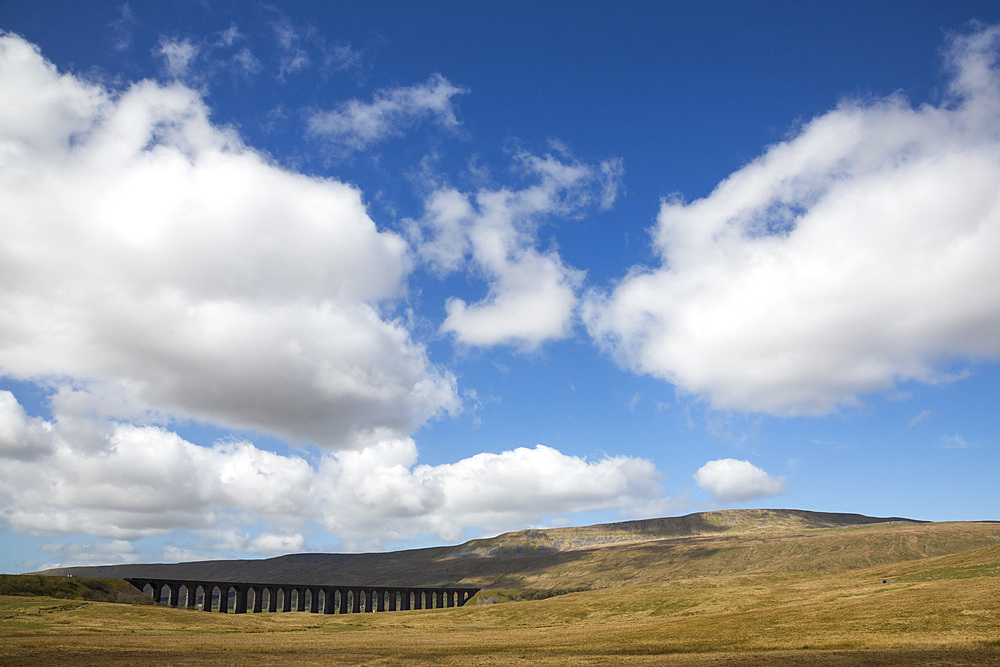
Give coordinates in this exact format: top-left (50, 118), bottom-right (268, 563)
top-left (42, 509), bottom-right (960, 589)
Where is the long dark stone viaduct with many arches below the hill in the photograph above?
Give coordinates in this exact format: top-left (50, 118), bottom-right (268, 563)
top-left (125, 577), bottom-right (479, 614)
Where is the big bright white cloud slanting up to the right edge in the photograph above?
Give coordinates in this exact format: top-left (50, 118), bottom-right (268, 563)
top-left (584, 28), bottom-right (1000, 415)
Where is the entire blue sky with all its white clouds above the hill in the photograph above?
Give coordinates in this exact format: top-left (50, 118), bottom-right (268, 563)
top-left (0, 0), bottom-right (1000, 572)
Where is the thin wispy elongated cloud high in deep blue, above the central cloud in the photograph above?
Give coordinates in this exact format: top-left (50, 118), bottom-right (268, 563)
top-left (309, 74), bottom-right (468, 150)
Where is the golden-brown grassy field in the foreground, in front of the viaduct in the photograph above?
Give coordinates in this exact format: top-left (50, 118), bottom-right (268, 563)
top-left (0, 546), bottom-right (1000, 665)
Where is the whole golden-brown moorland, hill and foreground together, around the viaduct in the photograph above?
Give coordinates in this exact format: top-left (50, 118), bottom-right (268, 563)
top-left (0, 510), bottom-right (1000, 665)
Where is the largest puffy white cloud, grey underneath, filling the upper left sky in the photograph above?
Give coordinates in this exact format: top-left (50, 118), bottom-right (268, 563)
top-left (0, 35), bottom-right (458, 449)
